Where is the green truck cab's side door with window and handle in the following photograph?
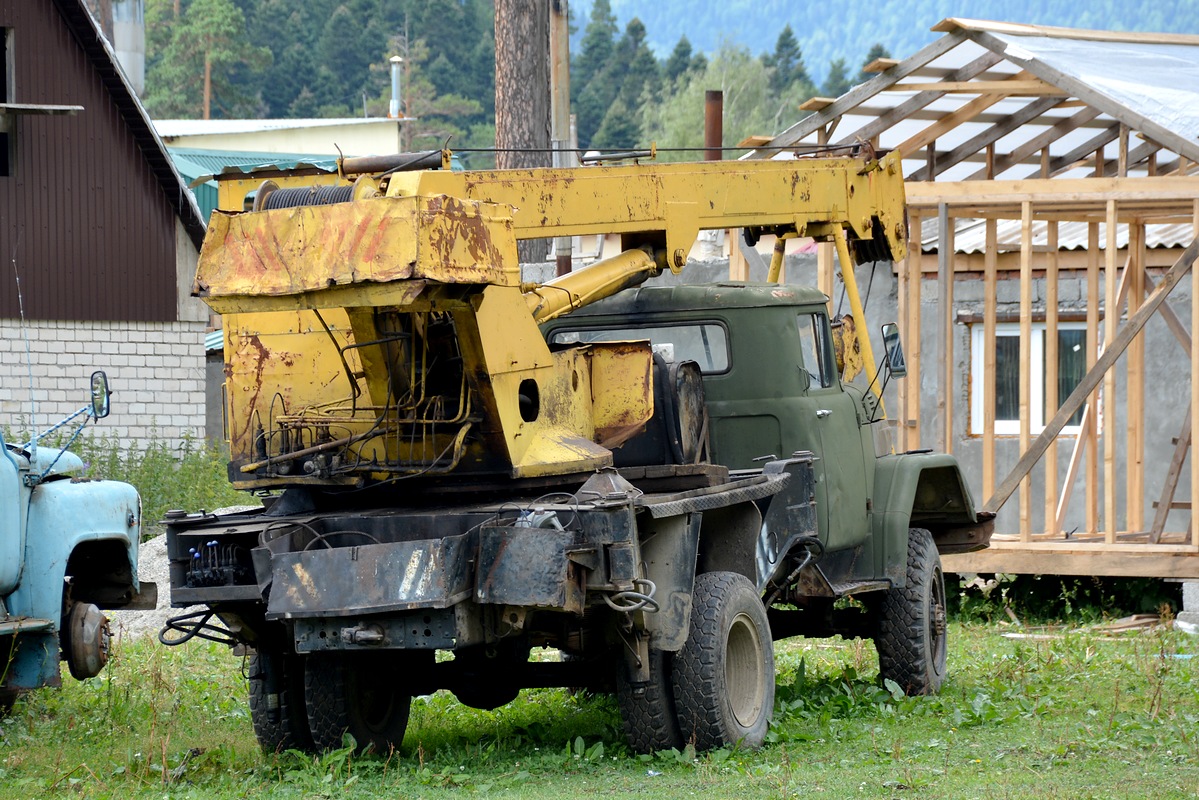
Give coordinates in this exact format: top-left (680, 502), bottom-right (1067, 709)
top-left (796, 312), bottom-right (870, 551)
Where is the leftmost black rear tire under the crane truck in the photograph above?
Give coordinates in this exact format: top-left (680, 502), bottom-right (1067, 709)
top-left (249, 648), bottom-right (313, 753)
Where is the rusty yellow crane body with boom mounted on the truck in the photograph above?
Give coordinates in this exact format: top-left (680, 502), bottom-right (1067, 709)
top-left (201, 149), bottom-right (906, 488)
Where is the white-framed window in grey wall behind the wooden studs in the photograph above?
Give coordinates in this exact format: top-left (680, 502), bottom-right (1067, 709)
top-left (970, 323), bottom-right (1086, 435)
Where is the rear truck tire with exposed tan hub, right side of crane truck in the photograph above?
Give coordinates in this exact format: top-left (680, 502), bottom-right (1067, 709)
top-left (673, 572), bottom-right (775, 750)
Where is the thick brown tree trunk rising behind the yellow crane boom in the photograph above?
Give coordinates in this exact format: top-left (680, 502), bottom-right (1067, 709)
top-left (495, 0), bottom-right (550, 263)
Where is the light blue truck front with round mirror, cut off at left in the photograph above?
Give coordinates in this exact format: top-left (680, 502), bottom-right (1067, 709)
top-left (0, 372), bottom-right (157, 712)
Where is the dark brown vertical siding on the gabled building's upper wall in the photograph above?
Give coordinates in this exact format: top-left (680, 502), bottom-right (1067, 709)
top-left (0, 0), bottom-right (176, 321)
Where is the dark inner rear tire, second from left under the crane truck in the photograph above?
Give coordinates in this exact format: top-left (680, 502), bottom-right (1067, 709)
top-left (303, 652), bottom-right (412, 754)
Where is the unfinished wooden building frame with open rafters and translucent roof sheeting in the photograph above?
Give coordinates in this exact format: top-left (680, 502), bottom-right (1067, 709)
top-left (754, 19), bottom-right (1199, 578)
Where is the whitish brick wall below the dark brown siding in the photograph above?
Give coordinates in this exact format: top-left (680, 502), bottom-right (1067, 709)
top-left (0, 319), bottom-right (205, 443)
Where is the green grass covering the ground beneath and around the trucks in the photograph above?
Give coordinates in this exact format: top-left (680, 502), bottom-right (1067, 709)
top-left (0, 624), bottom-right (1199, 800)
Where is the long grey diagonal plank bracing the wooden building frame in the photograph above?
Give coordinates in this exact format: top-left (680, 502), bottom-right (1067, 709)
top-left (982, 237), bottom-right (1199, 515)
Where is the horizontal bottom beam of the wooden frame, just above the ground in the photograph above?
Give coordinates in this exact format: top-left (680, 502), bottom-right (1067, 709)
top-left (941, 545), bottom-right (1199, 579)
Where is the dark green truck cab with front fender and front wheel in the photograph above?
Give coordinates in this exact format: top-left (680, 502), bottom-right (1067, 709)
top-left (543, 282), bottom-right (994, 693)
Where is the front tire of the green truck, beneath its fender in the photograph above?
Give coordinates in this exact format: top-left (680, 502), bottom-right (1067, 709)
top-left (874, 528), bottom-right (947, 694)
